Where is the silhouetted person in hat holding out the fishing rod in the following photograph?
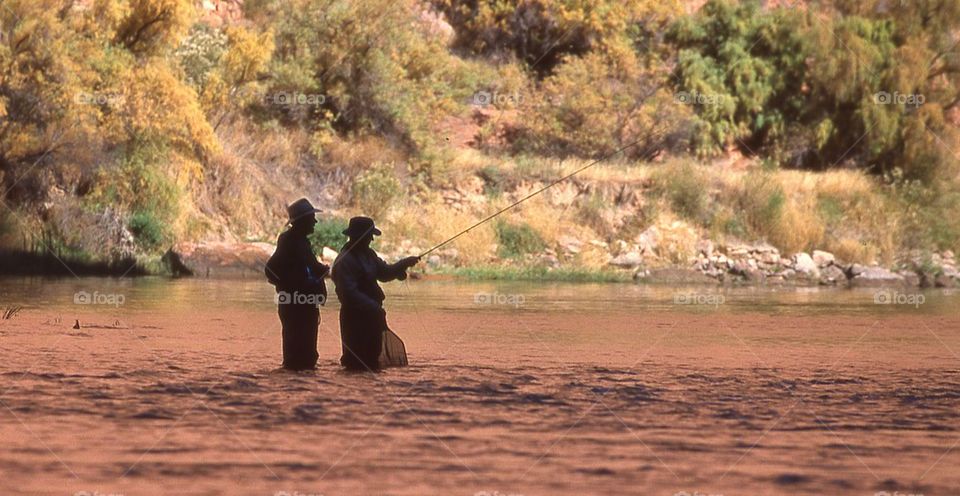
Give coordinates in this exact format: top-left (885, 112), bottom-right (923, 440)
top-left (333, 217), bottom-right (420, 370)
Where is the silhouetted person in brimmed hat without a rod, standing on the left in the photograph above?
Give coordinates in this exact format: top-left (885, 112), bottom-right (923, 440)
top-left (265, 198), bottom-right (330, 370)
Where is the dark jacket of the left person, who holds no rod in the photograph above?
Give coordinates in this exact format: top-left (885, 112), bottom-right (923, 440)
top-left (264, 229), bottom-right (328, 297)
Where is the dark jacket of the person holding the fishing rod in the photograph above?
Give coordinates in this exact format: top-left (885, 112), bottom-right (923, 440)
top-left (332, 245), bottom-right (407, 313)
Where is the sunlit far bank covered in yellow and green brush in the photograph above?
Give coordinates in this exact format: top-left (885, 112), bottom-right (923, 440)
top-left (0, 0), bottom-right (960, 278)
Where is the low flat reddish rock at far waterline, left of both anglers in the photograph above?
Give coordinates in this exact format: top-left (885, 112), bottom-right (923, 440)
top-left (161, 242), bottom-right (276, 278)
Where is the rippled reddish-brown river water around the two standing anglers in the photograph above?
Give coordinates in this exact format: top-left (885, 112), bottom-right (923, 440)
top-left (0, 279), bottom-right (960, 496)
